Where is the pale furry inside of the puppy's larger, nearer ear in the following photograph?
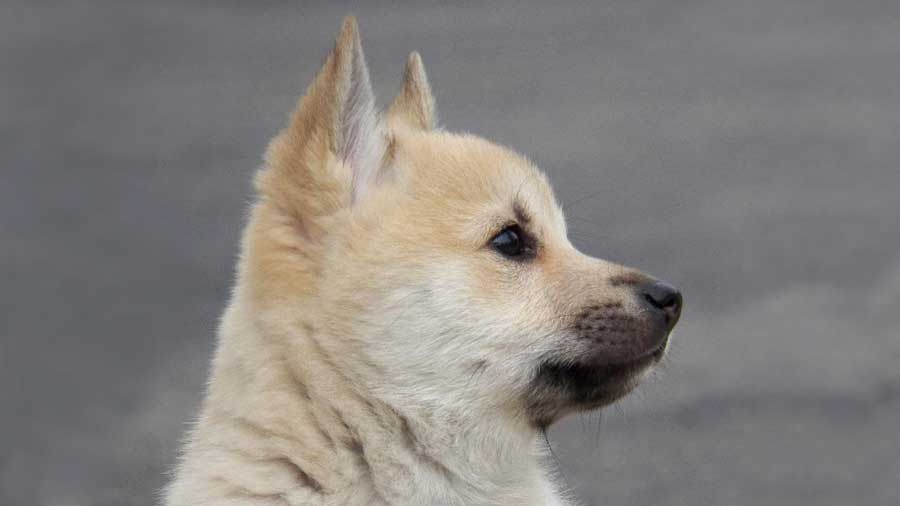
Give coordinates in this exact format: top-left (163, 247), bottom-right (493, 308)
top-left (339, 37), bottom-right (385, 203)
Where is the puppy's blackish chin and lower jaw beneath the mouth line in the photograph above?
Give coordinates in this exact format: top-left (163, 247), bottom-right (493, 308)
top-left (528, 347), bottom-right (665, 427)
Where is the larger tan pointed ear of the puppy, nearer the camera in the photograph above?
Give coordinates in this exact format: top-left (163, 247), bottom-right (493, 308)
top-left (267, 16), bottom-right (386, 208)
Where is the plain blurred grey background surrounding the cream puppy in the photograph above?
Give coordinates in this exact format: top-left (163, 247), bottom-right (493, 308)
top-left (0, 0), bottom-right (900, 506)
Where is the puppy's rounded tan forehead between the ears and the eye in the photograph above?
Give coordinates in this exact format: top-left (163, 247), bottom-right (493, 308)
top-left (396, 132), bottom-right (564, 227)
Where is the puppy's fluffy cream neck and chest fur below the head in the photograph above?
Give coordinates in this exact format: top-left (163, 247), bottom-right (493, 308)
top-left (163, 212), bottom-right (560, 505)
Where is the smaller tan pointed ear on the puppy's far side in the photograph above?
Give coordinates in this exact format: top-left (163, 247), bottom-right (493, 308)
top-left (388, 51), bottom-right (437, 130)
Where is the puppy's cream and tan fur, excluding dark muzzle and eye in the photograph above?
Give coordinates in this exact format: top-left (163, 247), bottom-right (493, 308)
top-left (165, 18), bottom-right (664, 506)
